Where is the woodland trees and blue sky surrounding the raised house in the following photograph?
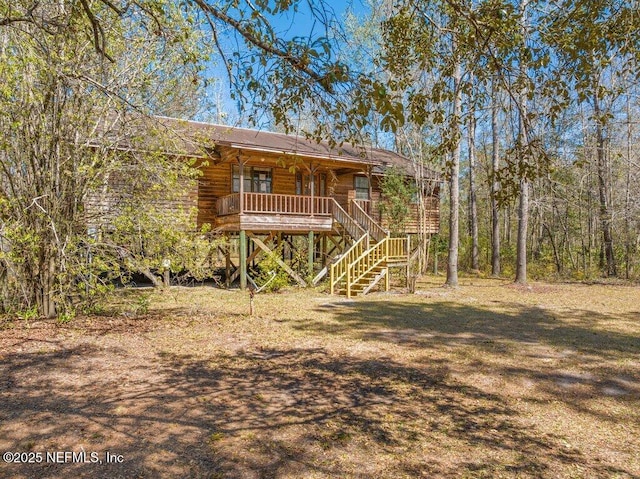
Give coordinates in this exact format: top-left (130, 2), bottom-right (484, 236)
top-left (0, 0), bottom-right (640, 319)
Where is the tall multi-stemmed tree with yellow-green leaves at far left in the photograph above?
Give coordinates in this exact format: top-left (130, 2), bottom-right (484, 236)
top-left (0, 1), bottom-right (210, 317)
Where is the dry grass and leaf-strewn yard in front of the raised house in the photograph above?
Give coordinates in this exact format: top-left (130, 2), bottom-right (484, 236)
top-left (0, 279), bottom-right (640, 478)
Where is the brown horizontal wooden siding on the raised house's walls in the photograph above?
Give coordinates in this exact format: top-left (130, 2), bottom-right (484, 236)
top-left (85, 124), bottom-right (440, 236)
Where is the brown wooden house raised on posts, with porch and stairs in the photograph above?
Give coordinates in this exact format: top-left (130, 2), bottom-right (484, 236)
top-left (131, 118), bottom-right (440, 296)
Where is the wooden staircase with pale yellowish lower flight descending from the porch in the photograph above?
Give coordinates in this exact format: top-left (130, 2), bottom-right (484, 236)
top-left (330, 201), bottom-right (409, 298)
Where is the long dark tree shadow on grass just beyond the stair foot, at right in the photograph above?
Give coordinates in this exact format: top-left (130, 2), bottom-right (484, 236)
top-left (308, 299), bottom-right (640, 358)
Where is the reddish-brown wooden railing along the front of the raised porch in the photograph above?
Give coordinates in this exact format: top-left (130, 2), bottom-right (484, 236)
top-left (216, 193), bottom-right (333, 216)
